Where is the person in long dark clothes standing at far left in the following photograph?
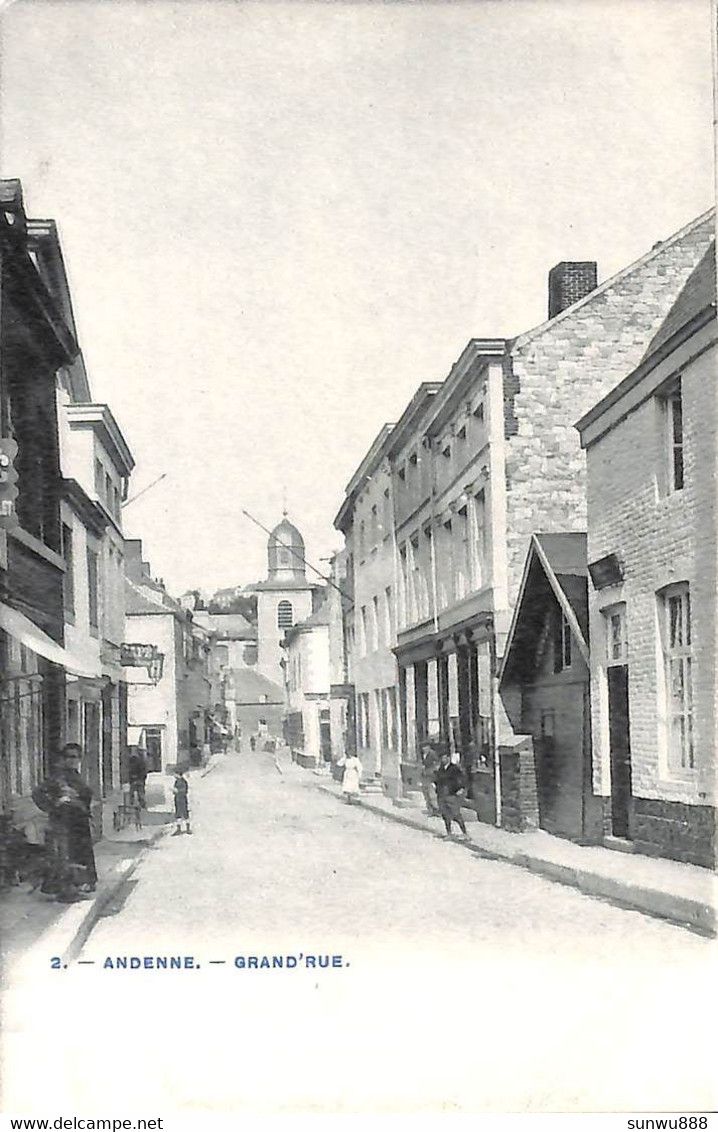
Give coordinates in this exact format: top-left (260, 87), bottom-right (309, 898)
top-left (33, 743), bottom-right (97, 903)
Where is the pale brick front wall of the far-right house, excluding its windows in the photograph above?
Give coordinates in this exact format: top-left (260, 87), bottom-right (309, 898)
top-left (581, 247), bottom-right (718, 865)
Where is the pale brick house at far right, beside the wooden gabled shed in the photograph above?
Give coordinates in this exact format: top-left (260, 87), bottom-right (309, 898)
top-left (578, 247), bottom-right (718, 865)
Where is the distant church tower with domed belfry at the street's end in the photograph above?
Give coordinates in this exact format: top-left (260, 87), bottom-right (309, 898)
top-left (254, 512), bottom-right (313, 685)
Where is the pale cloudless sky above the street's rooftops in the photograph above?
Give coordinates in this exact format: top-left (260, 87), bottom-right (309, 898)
top-left (0, 0), bottom-right (713, 593)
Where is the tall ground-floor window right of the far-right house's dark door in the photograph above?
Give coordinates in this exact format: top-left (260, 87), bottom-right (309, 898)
top-left (659, 583), bottom-right (695, 771)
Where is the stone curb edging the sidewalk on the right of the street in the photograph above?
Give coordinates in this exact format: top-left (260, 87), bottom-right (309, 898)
top-left (316, 783), bottom-right (717, 937)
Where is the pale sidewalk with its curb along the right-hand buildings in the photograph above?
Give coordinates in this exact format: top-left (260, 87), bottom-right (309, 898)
top-left (315, 778), bottom-right (718, 935)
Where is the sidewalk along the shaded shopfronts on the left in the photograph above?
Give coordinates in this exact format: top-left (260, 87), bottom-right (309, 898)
top-left (0, 754), bottom-right (222, 974)
